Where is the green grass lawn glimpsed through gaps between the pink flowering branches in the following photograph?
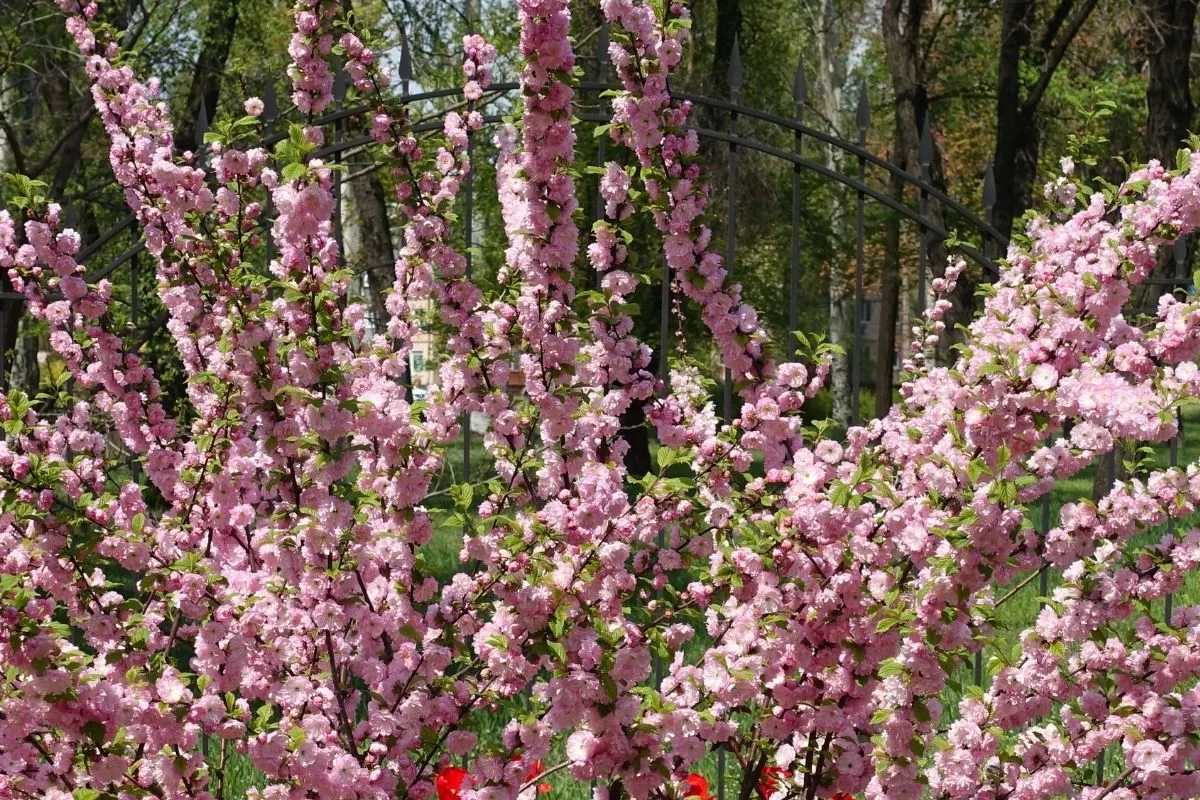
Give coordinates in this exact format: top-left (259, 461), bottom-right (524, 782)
top-left (209, 414), bottom-right (1200, 800)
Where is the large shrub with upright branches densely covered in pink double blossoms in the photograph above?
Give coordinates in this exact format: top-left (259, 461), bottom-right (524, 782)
top-left (0, 0), bottom-right (1200, 800)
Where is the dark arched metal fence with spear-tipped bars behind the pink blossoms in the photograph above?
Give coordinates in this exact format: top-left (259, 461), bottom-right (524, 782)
top-left (11, 36), bottom-right (1007, 408)
